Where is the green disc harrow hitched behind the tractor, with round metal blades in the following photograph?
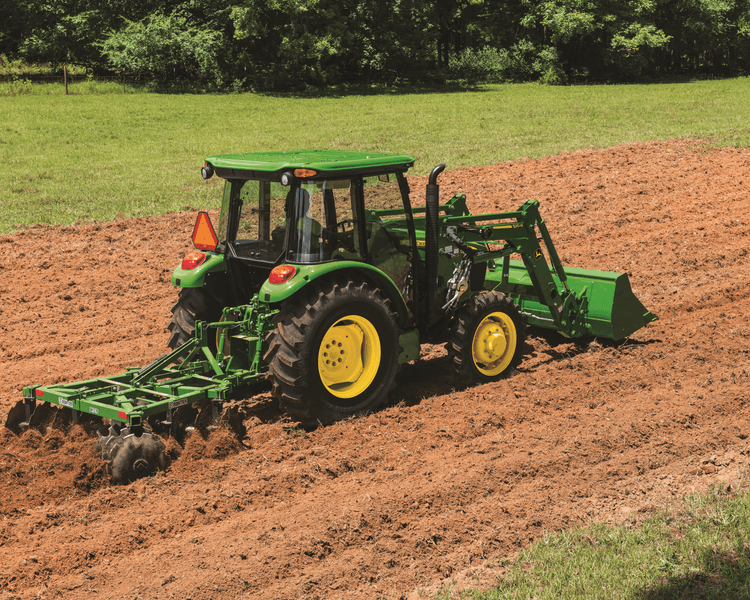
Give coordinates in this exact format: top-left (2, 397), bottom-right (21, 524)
top-left (5, 301), bottom-right (275, 483)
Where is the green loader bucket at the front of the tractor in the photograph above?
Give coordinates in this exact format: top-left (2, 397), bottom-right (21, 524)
top-left (500, 261), bottom-right (657, 340)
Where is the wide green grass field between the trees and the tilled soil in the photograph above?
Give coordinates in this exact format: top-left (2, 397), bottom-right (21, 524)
top-left (0, 78), bottom-right (750, 233)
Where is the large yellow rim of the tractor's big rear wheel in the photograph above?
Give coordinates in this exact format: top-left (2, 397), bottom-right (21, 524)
top-left (318, 315), bottom-right (380, 398)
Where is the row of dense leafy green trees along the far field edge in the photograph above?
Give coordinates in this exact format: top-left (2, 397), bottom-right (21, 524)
top-left (0, 0), bottom-right (750, 90)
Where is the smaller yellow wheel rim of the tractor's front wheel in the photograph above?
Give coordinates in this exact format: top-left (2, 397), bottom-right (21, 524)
top-left (471, 312), bottom-right (518, 377)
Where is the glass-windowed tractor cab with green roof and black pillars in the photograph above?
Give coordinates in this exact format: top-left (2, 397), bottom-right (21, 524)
top-left (203, 152), bottom-right (419, 310)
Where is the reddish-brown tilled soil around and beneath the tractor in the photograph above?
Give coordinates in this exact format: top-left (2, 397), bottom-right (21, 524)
top-left (0, 140), bottom-right (750, 600)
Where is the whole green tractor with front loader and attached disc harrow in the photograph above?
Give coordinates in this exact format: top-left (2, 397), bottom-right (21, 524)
top-left (7, 151), bottom-right (656, 481)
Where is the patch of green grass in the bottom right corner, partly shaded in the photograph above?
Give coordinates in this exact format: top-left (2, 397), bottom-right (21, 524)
top-left (435, 489), bottom-right (750, 600)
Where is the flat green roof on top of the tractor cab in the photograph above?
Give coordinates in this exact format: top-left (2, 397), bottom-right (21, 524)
top-left (206, 150), bottom-right (414, 178)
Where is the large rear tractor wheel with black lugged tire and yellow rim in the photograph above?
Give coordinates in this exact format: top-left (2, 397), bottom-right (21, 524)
top-left (264, 278), bottom-right (400, 427)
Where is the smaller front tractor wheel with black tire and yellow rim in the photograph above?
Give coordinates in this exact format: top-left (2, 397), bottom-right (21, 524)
top-left (448, 291), bottom-right (526, 383)
